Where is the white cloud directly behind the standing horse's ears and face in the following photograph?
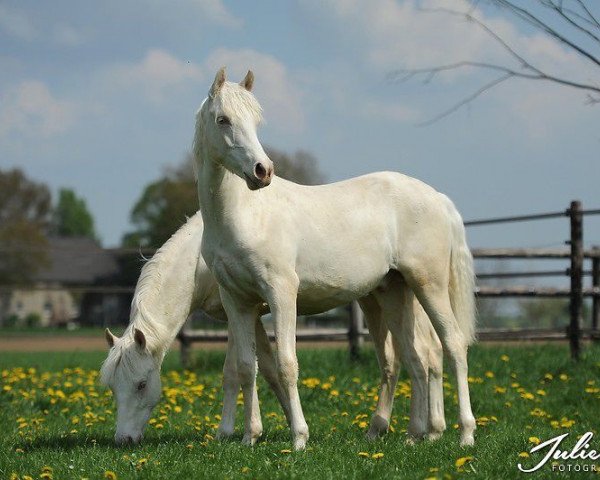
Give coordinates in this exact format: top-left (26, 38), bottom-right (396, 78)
top-left (204, 48), bottom-right (305, 133)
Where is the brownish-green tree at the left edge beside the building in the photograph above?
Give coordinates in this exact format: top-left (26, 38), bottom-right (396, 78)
top-left (0, 169), bottom-right (51, 284)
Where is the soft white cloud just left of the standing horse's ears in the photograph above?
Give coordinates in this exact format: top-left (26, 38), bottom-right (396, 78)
top-left (101, 50), bottom-right (203, 103)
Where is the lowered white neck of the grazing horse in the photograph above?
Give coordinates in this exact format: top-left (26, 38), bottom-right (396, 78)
top-left (130, 215), bottom-right (202, 359)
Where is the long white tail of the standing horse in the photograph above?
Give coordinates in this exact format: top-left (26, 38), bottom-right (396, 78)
top-left (448, 198), bottom-right (476, 345)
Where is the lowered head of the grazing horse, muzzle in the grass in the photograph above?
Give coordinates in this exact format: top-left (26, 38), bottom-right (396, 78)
top-left (100, 328), bottom-right (161, 444)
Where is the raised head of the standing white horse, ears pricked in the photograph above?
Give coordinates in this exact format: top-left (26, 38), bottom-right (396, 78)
top-left (196, 67), bottom-right (273, 190)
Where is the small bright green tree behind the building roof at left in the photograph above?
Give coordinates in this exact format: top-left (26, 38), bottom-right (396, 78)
top-left (53, 188), bottom-right (96, 239)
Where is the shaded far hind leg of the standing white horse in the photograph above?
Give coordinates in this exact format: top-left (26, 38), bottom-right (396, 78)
top-left (374, 274), bottom-right (429, 441)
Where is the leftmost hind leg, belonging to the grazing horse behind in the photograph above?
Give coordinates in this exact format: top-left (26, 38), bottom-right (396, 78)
top-left (359, 295), bottom-right (400, 440)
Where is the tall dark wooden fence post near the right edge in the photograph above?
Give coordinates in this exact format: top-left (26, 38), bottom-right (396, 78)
top-left (568, 200), bottom-right (583, 360)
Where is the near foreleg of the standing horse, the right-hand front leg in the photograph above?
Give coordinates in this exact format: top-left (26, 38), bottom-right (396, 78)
top-left (268, 279), bottom-right (308, 450)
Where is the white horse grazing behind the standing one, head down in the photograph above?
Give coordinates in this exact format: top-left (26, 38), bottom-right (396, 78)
top-left (101, 213), bottom-right (445, 444)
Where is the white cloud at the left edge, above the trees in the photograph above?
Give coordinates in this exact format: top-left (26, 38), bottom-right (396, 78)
top-left (0, 80), bottom-right (79, 139)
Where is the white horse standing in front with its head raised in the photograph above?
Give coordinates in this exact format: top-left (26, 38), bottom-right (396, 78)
top-left (194, 69), bottom-right (475, 449)
